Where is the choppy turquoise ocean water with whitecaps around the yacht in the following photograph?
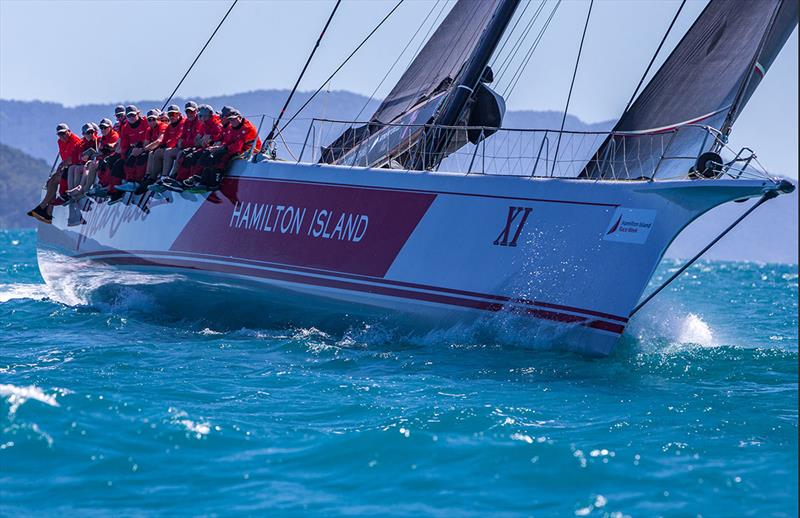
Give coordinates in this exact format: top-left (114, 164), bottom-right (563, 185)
top-left (0, 231), bottom-right (798, 517)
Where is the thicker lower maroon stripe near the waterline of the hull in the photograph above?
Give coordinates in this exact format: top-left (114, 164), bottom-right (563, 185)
top-left (84, 255), bottom-right (625, 334)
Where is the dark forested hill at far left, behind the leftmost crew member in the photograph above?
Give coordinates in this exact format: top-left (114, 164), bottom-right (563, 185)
top-left (0, 144), bottom-right (50, 228)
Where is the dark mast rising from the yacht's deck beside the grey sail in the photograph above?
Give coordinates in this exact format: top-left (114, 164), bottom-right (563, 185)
top-left (411, 0), bottom-right (520, 169)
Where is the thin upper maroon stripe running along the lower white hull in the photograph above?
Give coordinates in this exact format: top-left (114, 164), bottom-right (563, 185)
top-left (75, 250), bottom-right (628, 323)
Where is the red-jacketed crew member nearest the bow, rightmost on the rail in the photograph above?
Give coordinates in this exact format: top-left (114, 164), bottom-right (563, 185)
top-left (184, 108), bottom-right (261, 190)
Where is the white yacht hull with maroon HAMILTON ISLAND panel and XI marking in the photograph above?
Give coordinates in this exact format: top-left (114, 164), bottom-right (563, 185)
top-left (39, 162), bottom-right (775, 355)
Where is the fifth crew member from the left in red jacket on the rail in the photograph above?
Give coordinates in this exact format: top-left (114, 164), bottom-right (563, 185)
top-left (111, 105), bottom-right (150, 196)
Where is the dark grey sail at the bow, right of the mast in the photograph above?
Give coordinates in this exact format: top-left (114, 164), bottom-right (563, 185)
top-left (581, 0), bottom-right (798, 178)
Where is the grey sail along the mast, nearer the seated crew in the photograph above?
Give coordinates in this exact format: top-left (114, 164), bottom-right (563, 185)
top-left (320, 0), bottom-right (519, 167)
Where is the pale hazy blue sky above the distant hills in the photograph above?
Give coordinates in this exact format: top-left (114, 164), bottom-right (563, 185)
top-left (0, 0), bottom-right (798, 177)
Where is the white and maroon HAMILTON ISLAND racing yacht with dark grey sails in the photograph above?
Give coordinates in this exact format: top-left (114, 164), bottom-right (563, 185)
top-left (38, 0), bottom-right (798, 355)
